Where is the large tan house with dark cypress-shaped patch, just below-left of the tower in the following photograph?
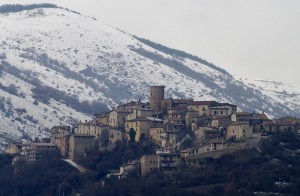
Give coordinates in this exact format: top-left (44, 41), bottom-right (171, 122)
top-left (125, 117), bottom-right (163, 142)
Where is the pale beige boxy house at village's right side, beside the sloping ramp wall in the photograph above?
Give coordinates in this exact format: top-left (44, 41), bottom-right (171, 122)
top-left (226, 122), bottom-right (253, 140)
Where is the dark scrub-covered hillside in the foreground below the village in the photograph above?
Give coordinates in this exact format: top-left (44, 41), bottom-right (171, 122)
top-left (0, 132), bottom-right (300, 195)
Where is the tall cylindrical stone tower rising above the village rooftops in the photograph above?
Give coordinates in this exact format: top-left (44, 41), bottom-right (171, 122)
top-left (150, 86), bottom-right (165, 111)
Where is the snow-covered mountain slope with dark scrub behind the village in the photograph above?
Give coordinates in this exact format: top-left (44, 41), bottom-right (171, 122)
top-left (0, 6), bottom-right (300, 149)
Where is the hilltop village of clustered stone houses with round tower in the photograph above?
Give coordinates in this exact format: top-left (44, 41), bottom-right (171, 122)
top-left (6, 86), bottom-right (300, 178)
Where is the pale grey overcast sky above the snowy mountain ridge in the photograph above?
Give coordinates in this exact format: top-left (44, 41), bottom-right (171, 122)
top-left (0, 0), bottom-right (300, 86)
